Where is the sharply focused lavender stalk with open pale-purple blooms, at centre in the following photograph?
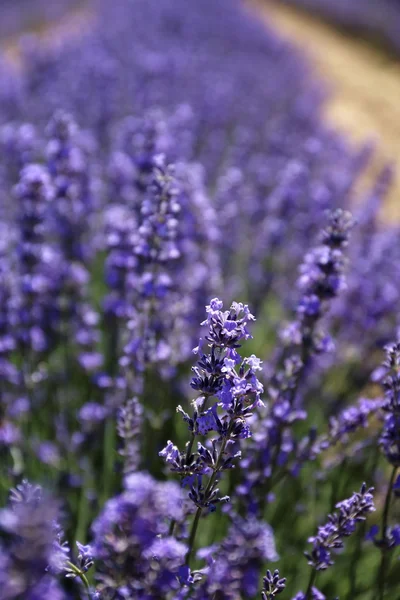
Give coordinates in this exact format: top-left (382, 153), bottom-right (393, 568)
top-left (160, 298), bottom-right (263, 566)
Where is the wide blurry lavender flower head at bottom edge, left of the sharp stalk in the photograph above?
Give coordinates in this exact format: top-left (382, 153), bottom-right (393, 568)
top-left (93, 473), bottom-right (186, 600)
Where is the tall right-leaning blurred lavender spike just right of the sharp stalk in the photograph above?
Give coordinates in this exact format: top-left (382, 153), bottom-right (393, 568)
top-left (238, 210), bottom-right (353, 512)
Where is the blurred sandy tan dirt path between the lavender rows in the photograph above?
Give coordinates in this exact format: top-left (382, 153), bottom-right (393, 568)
top-left (253, 0), bottom-right (400, 219)
